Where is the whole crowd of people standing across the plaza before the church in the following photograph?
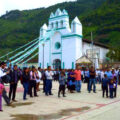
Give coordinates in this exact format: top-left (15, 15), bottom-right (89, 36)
top-left (0, 62), bottom-right (120, 111)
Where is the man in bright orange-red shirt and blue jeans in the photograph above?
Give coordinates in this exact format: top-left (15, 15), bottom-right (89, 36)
top-left (74, 66), bottom-right (82, 92)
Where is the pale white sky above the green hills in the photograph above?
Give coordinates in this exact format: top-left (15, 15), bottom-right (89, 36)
top-left (0, 0), bottom-right (76, 16)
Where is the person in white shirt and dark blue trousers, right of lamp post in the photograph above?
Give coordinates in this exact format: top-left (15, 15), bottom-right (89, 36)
top-left (45, 66), bottom-right (54, 96)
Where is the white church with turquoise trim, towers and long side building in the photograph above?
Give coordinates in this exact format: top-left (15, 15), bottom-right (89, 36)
top-left (39, 9), bottom-right (108, 69)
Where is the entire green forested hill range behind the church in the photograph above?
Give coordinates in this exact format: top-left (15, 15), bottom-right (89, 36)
top-left (0, 0), bottom-right (120, 60)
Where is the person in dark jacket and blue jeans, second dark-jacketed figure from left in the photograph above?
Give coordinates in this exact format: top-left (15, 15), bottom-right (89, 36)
top-left (22, 68), bottom-right (30, 100)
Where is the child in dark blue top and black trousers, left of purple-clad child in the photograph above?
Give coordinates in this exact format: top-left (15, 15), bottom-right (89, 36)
top-left (102, 74), bottom-right (109, 98)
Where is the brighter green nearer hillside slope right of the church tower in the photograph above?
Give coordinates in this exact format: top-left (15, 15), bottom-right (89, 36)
top-left (82, 0), bottom-right (120, 47)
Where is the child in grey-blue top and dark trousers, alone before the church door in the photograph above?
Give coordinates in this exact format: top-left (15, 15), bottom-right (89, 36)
top-left (58, 72), bottom-right (66, 97)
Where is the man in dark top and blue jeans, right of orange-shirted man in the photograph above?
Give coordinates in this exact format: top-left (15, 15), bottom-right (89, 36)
top-left (89, 66), bottom-right (96, 93)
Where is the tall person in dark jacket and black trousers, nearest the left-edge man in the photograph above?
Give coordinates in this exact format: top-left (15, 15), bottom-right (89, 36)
top-left (9, 65), bottom-right (20, 102)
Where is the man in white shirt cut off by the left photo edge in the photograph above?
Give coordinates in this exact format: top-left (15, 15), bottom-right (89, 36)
top-left (0, 62), bottom-right (10, 105)
